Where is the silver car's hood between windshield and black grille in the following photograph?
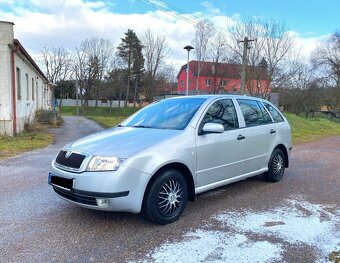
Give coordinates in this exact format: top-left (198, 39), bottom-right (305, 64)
top-left (65, 127), bottom-right (182, 158)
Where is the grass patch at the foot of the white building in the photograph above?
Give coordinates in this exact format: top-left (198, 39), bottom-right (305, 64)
top-left (0, 124), bottom-right (54, 160)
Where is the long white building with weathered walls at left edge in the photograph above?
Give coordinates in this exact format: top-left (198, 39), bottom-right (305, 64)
top-left (0, 21), bottom-right (52, 135)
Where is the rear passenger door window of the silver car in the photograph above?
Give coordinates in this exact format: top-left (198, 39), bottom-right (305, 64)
top-left (237, 99), bottom-right (272, 127)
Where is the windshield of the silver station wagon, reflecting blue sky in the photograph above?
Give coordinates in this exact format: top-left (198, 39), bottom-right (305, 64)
top-left (121, 98), bottom-right (205, 130)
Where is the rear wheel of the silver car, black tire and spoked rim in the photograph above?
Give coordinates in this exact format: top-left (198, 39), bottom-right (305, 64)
top-left (263, 148), bottom-right (286, 182)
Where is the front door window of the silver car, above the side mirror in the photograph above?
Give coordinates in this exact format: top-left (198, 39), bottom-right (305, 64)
top-left (200, 99), bottom-right (239, 131)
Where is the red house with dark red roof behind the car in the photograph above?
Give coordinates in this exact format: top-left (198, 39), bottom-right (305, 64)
top-left (177, 60), bottom-right (270, 95)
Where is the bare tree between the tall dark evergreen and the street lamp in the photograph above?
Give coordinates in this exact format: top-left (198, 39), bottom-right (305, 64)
top-left (141, 29), bottom-right (169, 101)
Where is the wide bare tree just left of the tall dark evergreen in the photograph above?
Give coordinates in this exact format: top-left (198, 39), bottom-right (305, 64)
top-left (73, 38), bottom-right (114, 106)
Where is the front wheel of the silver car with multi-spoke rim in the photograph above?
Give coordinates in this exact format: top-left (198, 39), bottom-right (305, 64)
top-left (142, 169), bottom-right (188, 225)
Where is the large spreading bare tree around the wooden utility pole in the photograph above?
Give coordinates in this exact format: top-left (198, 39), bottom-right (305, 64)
top-left (227, 19), bottom-right (296, 97)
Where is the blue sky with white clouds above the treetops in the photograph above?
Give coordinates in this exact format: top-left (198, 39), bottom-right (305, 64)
top-left (0, 0), bottom-right (340, 70)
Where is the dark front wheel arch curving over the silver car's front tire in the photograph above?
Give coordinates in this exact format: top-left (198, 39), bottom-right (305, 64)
top-left (143, 162), bottom-right (195, 202)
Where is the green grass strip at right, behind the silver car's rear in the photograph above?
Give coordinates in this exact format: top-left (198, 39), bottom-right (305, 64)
top-left (285, 113), bottom-right (340, 143)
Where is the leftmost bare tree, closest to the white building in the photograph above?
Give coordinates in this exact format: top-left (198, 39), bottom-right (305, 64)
top-left (41, 46), bottom-right (72, 108)
